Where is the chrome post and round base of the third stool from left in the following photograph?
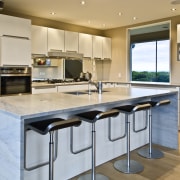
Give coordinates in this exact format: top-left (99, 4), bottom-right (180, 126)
top-left (114, 114), bottom-right (144, 174)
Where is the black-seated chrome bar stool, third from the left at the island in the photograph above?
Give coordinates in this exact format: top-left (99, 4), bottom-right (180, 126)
top-left (113, 103), bottom-right (151, 174)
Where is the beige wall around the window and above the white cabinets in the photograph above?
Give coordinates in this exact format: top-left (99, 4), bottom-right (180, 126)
top-left (3, 11), bottom-right (180, 83)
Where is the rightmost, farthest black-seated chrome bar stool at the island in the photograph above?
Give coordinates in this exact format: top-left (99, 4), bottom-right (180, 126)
top-left (138, 99), bottom-right (170, 159)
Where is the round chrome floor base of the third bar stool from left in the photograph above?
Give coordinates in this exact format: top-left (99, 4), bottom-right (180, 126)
top-left (114, 159), bottom-right (144, 174)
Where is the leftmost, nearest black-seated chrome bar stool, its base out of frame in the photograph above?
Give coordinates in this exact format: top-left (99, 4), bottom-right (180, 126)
top-left (25, 118), bottom-right (81, 180)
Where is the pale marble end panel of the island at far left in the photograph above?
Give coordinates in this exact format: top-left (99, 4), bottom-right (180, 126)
top-left (0, 112), bottom-right (22, 180)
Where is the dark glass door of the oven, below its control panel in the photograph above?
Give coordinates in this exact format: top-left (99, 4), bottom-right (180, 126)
top-left (0, 75), bottom-right (31, 95)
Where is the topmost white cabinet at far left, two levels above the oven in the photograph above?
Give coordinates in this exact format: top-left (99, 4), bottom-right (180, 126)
top-left (0, 14), bottom-right (31, 39)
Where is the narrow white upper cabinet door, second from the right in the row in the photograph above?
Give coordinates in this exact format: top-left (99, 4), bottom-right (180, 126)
top-left (93, 36), bottom-right (103, 59)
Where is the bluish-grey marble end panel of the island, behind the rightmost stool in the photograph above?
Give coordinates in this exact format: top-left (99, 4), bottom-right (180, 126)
top-left (152, 94), bottom-right (178, 149)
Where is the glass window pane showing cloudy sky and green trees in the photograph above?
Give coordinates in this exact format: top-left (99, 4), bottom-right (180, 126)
top-left (131, 40), bottom-right (169, 82)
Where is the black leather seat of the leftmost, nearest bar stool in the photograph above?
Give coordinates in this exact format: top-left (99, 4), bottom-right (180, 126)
top-left (27, 118), bottom-right (81, 135)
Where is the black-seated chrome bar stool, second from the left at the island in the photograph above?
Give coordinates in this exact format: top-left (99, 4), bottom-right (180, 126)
top-left (76, 109), bottom-right (119, 180)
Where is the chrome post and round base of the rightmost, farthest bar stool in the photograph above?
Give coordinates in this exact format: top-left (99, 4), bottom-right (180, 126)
top-left (138, 110), bottom-right (164, 159)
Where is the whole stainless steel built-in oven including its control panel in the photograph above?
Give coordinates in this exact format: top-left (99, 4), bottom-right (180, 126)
top-left (0, 66), bottom-right (31, 96)
